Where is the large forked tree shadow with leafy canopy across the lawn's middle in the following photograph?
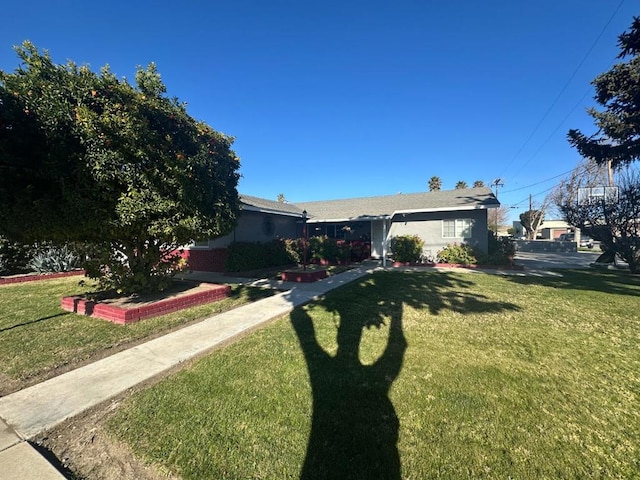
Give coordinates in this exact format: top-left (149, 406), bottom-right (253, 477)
top-left (290, 272), bottom-right (519, 480)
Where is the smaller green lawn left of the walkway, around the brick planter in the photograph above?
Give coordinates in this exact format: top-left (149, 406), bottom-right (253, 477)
top-left (0, 277), bottom-right (271, 394)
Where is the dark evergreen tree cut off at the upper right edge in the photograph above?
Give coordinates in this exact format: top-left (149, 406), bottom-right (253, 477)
top-left (569, 17), bottom-right (640, 168)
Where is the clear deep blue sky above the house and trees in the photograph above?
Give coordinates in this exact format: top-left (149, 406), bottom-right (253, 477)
top-left (0, 0), bottom-right (640, 219)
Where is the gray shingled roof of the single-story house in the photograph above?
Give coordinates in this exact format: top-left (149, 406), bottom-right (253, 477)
top-left (241, 187), bottom-right (500, 222)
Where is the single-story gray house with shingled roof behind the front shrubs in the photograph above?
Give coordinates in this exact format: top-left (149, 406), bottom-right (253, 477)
top-left (186, 187), bottom-right (500, 271)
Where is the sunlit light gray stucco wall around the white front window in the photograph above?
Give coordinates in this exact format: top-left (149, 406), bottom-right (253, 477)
top-left (389, 210), bottom-right (488, 258)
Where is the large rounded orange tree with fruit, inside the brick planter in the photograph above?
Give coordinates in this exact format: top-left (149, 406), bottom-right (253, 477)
top-left (0, 43), bottom-right (240, 293)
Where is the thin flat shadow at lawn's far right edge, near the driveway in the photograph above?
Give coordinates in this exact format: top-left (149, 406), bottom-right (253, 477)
top-left (505, 269), bottom-right (640, 298)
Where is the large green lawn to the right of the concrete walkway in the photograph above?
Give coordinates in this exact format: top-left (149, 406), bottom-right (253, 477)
top-left (108, 271), bottom-right (640, 480)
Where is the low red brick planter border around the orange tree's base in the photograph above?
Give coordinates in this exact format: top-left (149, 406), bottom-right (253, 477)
top-left (60, 284), bottom-right (231, 325)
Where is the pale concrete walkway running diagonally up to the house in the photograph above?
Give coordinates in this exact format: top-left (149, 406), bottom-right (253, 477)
top-left (0, 265), bottom-right (373, 480)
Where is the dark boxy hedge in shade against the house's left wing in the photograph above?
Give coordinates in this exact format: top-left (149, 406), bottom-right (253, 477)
top-left (224, 239), bottom-right (300, 272)
